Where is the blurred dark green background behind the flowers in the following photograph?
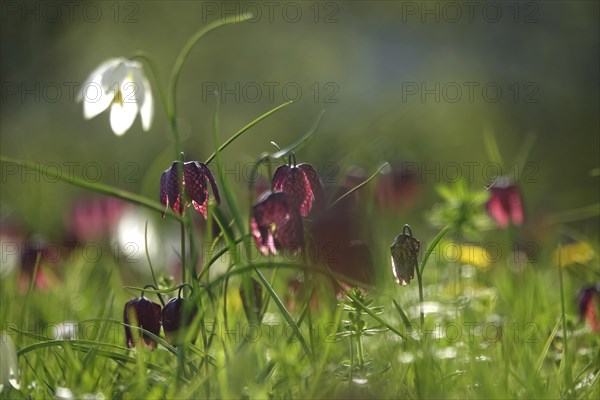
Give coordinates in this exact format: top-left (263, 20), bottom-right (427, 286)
top-left (0, 1), bottom-right (600, 237)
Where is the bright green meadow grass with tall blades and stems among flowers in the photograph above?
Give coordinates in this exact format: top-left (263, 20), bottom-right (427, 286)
top-left (0, 14), bottom-right (600, 399)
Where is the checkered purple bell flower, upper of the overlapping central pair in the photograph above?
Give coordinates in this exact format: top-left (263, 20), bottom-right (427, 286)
top-left (273, 156), bottom-right (325, 217)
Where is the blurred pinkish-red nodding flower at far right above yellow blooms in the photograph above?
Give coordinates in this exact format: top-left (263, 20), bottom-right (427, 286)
top-left (486, 177), bottom-right (523, 228)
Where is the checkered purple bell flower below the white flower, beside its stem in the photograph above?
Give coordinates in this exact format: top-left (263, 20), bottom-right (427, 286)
top-left (160, 161), bottom-right (221, 218)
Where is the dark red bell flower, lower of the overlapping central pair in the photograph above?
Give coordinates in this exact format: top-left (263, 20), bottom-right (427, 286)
top-left (250, 192), bottom-right (304, 256)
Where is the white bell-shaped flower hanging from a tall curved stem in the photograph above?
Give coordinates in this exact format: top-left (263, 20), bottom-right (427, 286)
top-left (79, 58), bottom-right (154, 136)
